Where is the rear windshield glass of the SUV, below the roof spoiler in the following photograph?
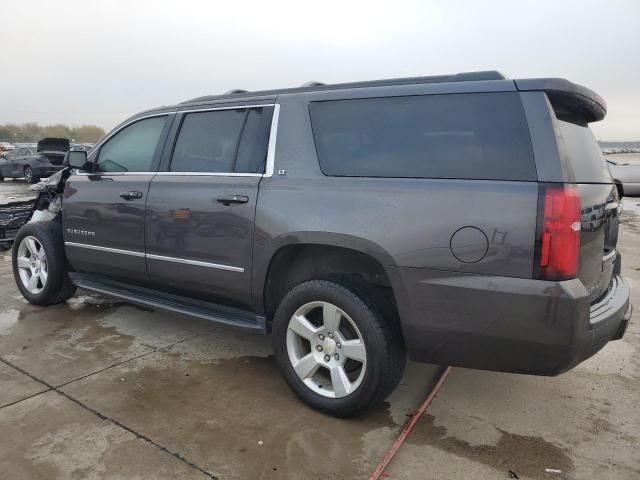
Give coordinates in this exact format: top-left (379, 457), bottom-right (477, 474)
top-left (558, 120), bottom-right (613, 183)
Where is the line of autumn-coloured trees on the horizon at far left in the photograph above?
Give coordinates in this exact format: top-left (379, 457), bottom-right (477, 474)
top-left (0, 122), bottom-right (104, 143)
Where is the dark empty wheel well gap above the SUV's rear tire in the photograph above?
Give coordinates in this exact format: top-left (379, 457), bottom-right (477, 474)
top-left (264, 244), bottom-right (395, 317)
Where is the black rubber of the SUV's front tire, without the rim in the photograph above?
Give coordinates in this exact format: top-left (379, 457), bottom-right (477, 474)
top-left (11, 222), bottom-right (76, 306)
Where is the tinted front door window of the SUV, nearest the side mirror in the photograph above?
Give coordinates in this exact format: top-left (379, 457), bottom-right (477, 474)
top-left (98, 117), bottom-right (166, 172)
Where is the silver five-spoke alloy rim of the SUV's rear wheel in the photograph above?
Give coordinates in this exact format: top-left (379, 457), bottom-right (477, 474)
top-left (287, 302), bottom-right (367, 398)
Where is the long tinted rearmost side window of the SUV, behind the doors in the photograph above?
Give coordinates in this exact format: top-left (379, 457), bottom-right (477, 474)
top-left (309, 92), bottom-right (536, 180)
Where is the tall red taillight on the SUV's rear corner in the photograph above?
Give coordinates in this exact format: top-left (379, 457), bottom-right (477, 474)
top-left (540, 185), bottom-right (580, 279)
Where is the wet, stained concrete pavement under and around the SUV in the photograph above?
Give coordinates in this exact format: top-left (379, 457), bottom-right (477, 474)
top-left (0, 182), bottom-right (640, 479)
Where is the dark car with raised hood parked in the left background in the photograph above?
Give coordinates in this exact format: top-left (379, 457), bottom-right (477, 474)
top-left (0, 138), bottom-right (69, 183)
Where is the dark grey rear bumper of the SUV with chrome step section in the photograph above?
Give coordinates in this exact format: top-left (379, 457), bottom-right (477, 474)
top-left (389, 267), bottom-right (632, 375)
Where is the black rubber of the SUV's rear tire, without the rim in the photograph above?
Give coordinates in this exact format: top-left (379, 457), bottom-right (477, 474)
top-left (272, 276), bottom-right (406, 417)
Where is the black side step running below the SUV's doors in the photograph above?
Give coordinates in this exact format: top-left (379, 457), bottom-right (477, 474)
top-left (69, 273), bottom-right (267, 333)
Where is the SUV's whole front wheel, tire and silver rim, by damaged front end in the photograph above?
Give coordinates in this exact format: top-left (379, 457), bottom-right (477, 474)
top-left (12, 222), bottom-right (75, 305)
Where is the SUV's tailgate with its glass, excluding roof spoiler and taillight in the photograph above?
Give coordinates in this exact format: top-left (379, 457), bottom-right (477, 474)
top-left (557, 117), bottom-right (619, 302)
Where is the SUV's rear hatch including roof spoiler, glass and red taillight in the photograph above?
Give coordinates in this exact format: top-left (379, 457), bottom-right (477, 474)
top-left (515, 78), bottom-right (620, 303)
